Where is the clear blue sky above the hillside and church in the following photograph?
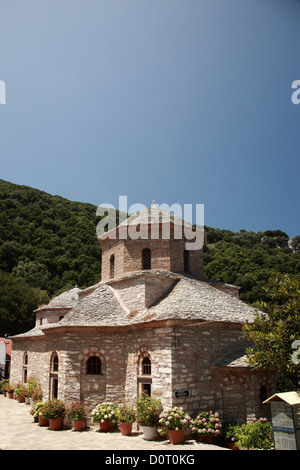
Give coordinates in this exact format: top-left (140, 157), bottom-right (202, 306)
top-left (0, 0), bottom-right (300, 237)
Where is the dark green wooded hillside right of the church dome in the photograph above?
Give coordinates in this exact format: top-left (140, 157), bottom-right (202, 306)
top-left (204, 227), bottom-right (300, 304)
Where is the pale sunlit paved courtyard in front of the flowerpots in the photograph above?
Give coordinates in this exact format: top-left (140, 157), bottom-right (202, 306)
top-left (0, 395), bottom-right (227, 455)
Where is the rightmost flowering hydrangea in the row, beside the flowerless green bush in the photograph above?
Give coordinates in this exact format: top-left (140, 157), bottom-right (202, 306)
top-left (190, 411), bottom-right (222, 444)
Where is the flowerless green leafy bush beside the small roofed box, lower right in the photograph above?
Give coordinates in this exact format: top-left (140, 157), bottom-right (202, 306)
top-left (236, 418), bottom-right (273, 450)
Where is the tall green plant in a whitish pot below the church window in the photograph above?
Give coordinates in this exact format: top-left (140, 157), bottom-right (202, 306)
top-left (136, 392), bottom-right (162, 441)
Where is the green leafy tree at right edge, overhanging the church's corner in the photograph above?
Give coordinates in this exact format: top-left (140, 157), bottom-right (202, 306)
top-left (242, 275), bottom-right (300, 391)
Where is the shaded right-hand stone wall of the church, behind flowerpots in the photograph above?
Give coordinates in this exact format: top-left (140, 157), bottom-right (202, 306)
top-left (172, 324), bottom-right (276, 423)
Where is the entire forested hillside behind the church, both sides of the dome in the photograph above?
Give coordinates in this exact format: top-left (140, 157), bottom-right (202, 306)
top-left (0, 180), bottom-right (300, 336)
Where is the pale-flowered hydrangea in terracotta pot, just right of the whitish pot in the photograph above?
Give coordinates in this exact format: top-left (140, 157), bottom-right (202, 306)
top-left (159, 406), bottom-right (191, 444)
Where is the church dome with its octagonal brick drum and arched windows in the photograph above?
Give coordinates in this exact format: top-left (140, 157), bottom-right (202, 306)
top-left (98, 206), bottom-right (204, 281)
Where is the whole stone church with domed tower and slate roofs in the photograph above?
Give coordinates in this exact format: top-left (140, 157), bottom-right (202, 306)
top-left (11, 207), bottom-right (276, 422)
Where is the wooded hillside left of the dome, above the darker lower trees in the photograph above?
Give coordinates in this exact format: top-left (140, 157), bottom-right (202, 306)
top-left (0, 180), bottom-right (101, 296)
